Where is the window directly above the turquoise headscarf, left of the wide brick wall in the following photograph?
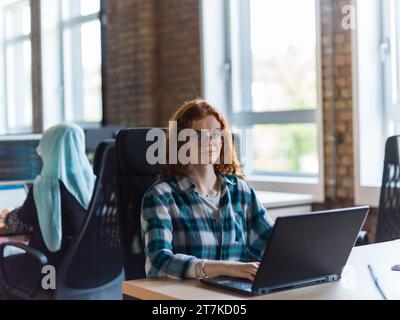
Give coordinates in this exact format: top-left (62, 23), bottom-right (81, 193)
top-left (41, 0), bottom-right (102, 127)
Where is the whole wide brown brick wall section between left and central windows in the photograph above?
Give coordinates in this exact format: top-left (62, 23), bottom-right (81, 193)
top-left (104, 0), bottom-right (201, 126)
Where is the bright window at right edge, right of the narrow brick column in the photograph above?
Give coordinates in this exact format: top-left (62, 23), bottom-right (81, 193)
top-left (353, 0), bottom-right (400, 206)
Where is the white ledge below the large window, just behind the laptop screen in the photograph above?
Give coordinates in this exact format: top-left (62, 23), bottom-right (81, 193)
top-left (256, 191), bottom-right (314, 220)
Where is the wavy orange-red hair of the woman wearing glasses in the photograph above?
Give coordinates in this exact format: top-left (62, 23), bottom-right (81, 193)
top-left (161, 99), bottom-right (242, 179)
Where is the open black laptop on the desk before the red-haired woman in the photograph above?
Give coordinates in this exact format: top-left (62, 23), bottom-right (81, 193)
top-left (200, 207), bottom-right (369, 295)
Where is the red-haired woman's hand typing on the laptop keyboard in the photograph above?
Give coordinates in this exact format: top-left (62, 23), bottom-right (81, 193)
top-left (199, 261), bottom-right (260, 281)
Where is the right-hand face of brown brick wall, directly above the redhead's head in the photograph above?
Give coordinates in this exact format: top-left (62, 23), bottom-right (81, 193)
top-left (156, 0), bottom-right (201, 125)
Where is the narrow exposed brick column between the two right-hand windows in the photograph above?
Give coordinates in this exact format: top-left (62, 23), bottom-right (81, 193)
top-left (322, 0), bottom-right (354, 203)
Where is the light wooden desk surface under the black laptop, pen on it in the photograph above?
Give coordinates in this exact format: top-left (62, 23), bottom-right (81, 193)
top-left (122, 240), bottom-right (400, 300)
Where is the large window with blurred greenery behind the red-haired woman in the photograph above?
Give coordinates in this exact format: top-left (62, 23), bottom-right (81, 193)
top-left (202, 0), bottom-right (324, 200)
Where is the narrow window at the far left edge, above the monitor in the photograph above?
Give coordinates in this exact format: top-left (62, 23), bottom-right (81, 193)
top-left (0, 0), bottom-right (32, 133)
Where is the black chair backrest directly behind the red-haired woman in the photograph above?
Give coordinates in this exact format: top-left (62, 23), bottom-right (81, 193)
top-left (116, 128), bottom-right (160, 280)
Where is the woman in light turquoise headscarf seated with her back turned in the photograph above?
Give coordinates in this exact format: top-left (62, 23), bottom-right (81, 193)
top-left (0, 124), bottom-right (95, 296)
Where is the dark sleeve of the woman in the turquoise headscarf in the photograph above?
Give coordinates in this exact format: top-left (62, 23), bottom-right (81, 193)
top-left (4, 188), bottom-right (36, 233)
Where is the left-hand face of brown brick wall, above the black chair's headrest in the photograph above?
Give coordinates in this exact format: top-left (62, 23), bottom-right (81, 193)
top-left (103, 0), bottom-right (157, 126)
